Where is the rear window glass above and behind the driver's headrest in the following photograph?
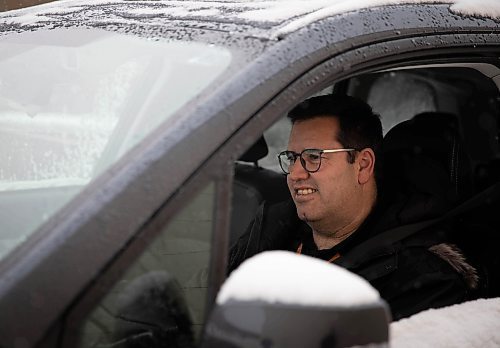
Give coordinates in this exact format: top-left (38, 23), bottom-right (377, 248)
top-left (348, 64), bottom-right (500, 165)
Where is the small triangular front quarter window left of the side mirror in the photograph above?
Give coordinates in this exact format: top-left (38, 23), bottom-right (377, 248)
top-left (69, 182), bottom-right (215, 348)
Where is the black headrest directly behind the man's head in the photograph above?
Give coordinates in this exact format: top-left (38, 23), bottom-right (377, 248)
top-left (382, 112), bottom-right (472, 217)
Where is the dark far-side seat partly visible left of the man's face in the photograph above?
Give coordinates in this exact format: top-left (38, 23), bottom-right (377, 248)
top-left (229, 137), bottom-right (290, 245)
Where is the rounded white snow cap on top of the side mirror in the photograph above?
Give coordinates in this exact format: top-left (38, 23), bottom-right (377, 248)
top-left (217, 251), bottom-right (380, 307)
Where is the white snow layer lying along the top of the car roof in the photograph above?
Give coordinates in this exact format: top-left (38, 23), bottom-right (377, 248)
top-left (0, 0), bottom-right (500, 39)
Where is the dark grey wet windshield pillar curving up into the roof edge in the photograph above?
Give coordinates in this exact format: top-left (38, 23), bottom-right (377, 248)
top-left (0, 1), bottom-right (500, 347)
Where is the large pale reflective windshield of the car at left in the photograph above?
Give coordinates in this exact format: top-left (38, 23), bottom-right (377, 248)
top-left (0, 29), bottom-right (231, 259)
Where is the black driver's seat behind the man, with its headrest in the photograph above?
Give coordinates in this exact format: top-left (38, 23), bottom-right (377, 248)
top-left (382, 112), bottom-right (500, 296)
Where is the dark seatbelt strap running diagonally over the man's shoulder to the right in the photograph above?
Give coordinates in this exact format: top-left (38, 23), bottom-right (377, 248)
top-left (336, 182), bottom-right (500, 268)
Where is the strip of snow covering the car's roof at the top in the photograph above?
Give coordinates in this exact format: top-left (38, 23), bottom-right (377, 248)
top-left (0, 0), bottom-right (500, 38)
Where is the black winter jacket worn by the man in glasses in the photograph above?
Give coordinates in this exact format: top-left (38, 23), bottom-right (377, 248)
top-left (228, 197), bottom-right (478, 320)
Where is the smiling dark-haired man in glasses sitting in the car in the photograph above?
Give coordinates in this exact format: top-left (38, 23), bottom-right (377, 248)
top-left (229, 96), bottom-right (477, 320)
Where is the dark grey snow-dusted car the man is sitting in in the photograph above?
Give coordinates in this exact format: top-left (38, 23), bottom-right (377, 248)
top-left (0, 0), bottom-right (500, 347)
